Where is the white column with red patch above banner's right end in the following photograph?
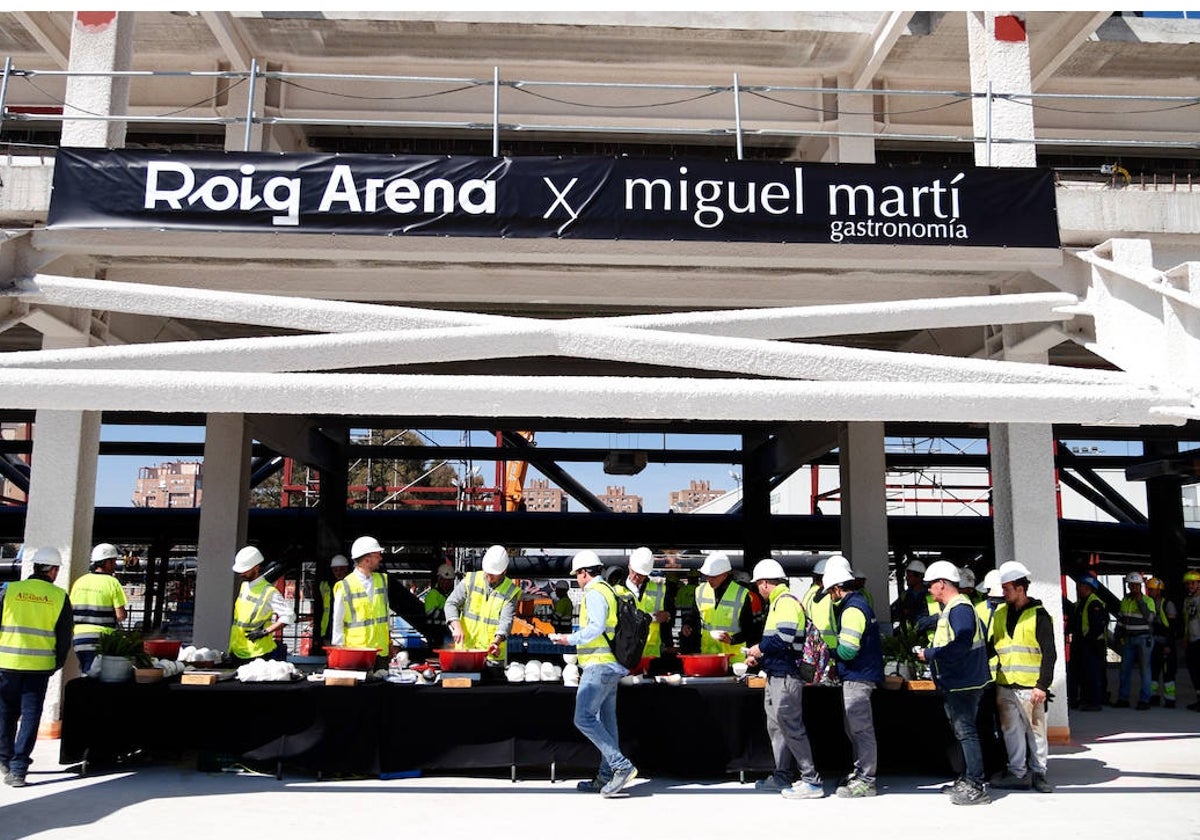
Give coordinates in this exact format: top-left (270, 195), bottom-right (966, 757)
top-left (966, 12), bottom-right (1037, 167)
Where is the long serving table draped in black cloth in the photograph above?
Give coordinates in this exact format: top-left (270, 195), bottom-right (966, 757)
top-left (60, 678), bottom-right (1003, 779)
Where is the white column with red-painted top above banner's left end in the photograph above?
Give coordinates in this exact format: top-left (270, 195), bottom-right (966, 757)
top-left (62, 12), bottom-right (133, 149)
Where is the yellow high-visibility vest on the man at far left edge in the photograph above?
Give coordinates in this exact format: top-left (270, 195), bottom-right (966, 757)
top-left (0, 577), bottom-right (67, 673)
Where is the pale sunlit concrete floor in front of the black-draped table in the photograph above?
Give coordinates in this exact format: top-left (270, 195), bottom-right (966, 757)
top-left (0, 708), bottom-right (1200, 840)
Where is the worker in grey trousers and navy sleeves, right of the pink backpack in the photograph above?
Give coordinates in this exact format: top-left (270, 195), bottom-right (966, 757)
top-left (824, 556), bottom-right (883, 799)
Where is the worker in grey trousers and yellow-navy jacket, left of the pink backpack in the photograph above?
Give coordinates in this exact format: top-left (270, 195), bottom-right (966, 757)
top-left (746, 558), bottom-right (824, 799)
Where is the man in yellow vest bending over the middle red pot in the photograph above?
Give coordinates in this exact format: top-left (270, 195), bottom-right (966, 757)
top-left (445, 545), bottom-right (521, 665)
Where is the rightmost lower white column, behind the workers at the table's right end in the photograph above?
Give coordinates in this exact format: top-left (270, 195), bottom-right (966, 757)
top-left (988, 424), bottom-right (1070, 743)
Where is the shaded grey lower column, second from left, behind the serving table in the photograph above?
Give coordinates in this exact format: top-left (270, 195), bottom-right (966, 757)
top-left (193, 414), bottom-right (250, 650)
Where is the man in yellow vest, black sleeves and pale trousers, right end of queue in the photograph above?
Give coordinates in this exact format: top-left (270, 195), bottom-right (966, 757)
top-left (988, 560), bottom-right (1058, 793)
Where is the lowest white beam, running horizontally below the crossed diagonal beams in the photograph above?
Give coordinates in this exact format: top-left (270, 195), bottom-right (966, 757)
top-left (0, 370), bottom-right (1198, 425)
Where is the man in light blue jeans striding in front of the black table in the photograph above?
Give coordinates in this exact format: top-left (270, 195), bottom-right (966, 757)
top-left (550, 550), bottom-right (637, 797)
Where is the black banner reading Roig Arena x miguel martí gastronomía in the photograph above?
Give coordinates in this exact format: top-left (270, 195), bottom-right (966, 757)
top-left (47, 149), bottom-right (1058, 247)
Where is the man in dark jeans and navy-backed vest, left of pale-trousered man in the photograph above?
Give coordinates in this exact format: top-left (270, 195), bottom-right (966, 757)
top-left (916, 560), bottom-right (991, 805)
